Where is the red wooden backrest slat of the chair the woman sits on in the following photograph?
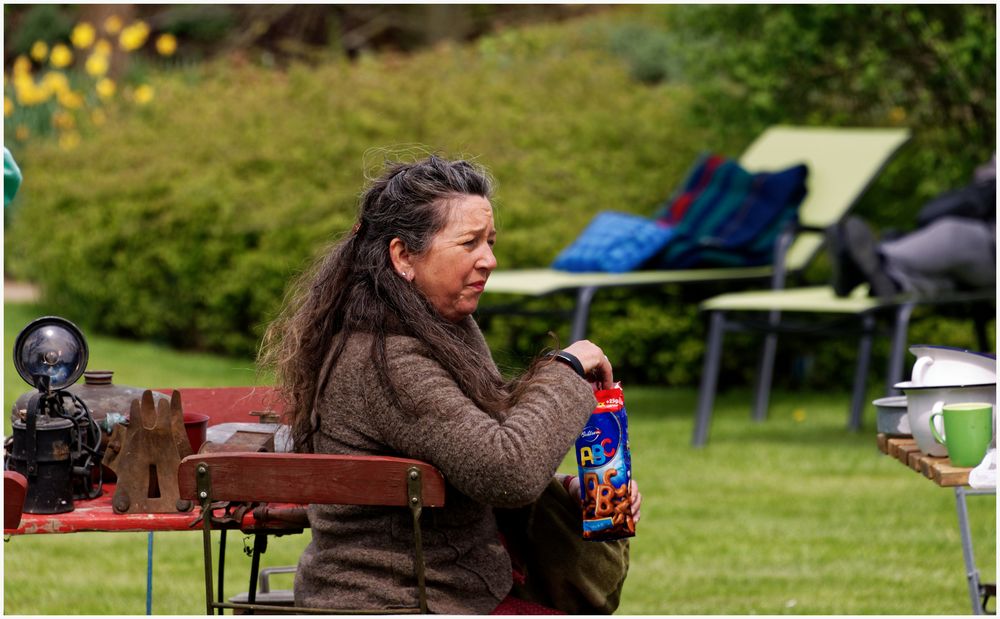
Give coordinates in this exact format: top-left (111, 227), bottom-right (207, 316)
top-left (177, 452), bottom-right (445, 507)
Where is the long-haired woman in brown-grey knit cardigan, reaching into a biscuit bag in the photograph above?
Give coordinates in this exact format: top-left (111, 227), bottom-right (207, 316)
top-left (263, 156), bottom-right (641, 614)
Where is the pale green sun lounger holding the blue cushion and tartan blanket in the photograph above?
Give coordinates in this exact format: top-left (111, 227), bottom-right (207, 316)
top-left (486, 126), bottom-right (910, 342)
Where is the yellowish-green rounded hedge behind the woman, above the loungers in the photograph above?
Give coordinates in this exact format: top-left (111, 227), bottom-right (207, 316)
top-left (7, 13), bottom-right (704, 354)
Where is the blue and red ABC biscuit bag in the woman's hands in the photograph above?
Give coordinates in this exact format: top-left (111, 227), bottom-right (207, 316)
top-left (576, 383), bottom-right (635, 541)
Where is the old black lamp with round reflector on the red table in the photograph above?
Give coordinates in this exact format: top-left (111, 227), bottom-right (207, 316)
top-left (4, 316), bottom-right (103, 514)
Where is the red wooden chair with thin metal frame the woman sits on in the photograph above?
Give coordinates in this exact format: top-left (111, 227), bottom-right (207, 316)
top-left (178, 452), bottom-right (444, 615)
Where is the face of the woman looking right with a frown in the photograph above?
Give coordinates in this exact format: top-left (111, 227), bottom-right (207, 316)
top-left (412, 196), bottom-right (497, 322)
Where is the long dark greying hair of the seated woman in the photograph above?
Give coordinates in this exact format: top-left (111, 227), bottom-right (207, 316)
top-left (260, 156), bottom-right (540, 451)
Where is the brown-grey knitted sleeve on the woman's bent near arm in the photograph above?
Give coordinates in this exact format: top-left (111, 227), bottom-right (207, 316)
top-left (371, 338), bottom-right (596, 507)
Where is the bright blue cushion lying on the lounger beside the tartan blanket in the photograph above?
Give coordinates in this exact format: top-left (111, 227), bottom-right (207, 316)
top-left (552, 211), bottom-right (673, 273)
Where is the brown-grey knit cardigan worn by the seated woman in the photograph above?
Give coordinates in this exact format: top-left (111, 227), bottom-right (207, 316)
top-left (295, 317), bottom-right (596, 614)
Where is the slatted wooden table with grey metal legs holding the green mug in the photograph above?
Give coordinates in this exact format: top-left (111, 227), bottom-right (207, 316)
top-left (878, 433), bottom-right (997, 615)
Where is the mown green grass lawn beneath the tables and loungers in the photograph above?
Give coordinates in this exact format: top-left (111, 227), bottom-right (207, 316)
top-left (3, 305), bottom-right (996, 615)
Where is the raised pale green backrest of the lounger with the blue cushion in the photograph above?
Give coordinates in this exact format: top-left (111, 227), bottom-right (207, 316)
top-left (740, 125), bottom-right (910, 271)
